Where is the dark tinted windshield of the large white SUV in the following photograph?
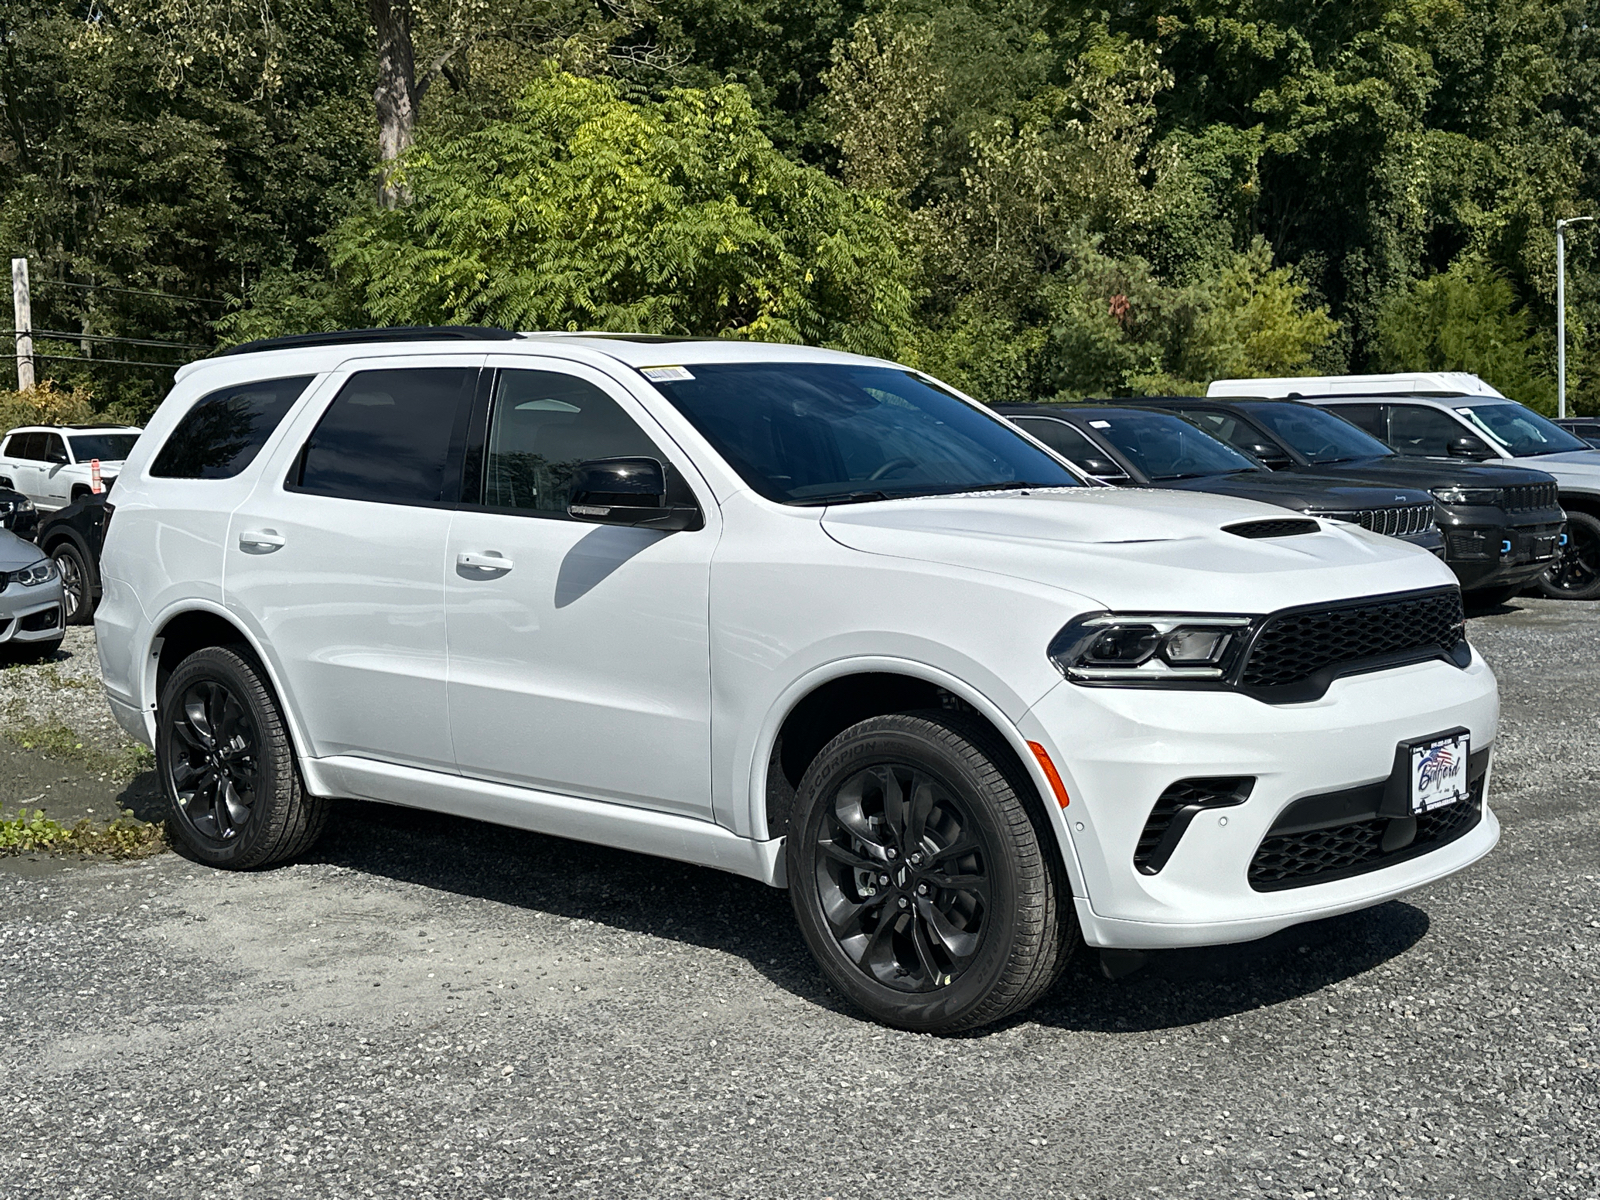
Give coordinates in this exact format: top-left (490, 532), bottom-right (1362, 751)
top-left (643, 363), bottom-right (1083, 504)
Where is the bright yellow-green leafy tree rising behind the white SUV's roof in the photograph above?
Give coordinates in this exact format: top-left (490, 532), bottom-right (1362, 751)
top-left (230, 72), bottom-right (909, 354)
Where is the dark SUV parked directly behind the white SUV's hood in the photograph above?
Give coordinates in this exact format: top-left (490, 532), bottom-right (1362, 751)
top-left (995, 403), bottom-right (1445, 557)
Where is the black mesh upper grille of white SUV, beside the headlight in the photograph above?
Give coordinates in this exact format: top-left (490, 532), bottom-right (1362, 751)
top-left (1240, 589), bottom-right (1464, 688)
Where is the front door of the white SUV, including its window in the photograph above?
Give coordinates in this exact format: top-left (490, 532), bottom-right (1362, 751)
top-left (445, 358), bottom-right (718, 819)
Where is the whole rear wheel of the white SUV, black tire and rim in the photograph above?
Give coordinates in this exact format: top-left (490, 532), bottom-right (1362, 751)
top-left (155, 646), bottom-right (328, 870)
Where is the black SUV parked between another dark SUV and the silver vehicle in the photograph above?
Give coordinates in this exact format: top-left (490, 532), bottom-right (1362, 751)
top-left (1106, 395), bottom-right (1566, 605)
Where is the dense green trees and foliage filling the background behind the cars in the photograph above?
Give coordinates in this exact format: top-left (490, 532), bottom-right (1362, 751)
top-left (0, 0), bottom-right (1600, 413)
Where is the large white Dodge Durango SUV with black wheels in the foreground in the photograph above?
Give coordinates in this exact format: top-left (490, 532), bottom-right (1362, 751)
top-left (96, 330), bottom-right (1499, 1032)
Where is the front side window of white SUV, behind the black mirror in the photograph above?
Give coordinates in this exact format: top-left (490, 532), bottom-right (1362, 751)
top-left (483, 370), bottom-right (674, 517)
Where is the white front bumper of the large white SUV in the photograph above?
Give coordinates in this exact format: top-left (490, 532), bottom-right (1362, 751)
top-left (1022, 654), bottom-right (1499, 949)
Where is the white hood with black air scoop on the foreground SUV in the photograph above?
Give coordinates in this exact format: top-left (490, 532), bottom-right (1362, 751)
top-left (822, 488), bottom-right (1456, 613)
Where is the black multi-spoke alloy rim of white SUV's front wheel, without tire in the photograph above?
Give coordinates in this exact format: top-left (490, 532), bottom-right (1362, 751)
top-left (816, 763), bottom-right (994, 992)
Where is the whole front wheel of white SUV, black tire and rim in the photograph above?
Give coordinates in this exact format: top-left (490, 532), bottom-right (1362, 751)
top-left (786, 710), bottom-right (1075, 1034)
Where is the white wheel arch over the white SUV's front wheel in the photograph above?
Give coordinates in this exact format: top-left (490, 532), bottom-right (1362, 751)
top-left (750, 659), bottom-right (1085, 894)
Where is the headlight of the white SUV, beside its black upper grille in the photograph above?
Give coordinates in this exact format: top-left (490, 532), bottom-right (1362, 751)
top-left (1050, 613), bottom-right (1254, 683)
